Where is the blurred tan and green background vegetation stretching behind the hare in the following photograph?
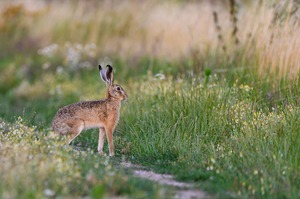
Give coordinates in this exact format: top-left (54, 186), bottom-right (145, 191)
top-left (0, 0), bottom-right (300, 122)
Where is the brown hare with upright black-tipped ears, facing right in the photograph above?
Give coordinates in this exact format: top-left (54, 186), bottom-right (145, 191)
top-left (52, 65), bottom-right (127, 156)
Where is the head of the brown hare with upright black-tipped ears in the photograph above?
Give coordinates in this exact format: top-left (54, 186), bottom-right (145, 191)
top-left (99, 65), bottom-right (128, 101)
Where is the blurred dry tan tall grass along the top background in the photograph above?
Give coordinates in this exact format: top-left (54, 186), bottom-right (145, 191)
top-left (1, 1), bottom-right (300, 78)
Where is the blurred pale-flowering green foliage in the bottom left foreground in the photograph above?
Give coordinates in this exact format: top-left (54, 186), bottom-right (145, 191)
top-left (0, 118), bottom-right (164, 198)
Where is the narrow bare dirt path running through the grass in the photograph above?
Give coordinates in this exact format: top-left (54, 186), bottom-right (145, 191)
top-left (121, 162), bottom-right (212, 199)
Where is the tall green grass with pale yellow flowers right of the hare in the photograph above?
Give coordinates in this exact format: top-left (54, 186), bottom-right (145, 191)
top-left (119, 77), bottom-right (300, 198)
